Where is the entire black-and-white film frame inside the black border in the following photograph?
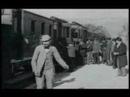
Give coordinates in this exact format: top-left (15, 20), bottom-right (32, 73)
top-left (1, 8), bottom-right (129, 90)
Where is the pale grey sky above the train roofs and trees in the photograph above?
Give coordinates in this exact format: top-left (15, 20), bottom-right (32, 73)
top-left (24, 9), bottom-right (129, 37)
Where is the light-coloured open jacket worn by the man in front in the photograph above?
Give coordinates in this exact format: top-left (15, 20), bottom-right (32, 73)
top-left (31, 45), bottom-right (67, 73)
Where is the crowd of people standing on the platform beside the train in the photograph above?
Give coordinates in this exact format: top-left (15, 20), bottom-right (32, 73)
top-left (67, 37), bottom-right (127, 76)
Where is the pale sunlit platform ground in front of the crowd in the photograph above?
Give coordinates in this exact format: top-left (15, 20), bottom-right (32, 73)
top-left (26, 64), bottom-right (129, 89)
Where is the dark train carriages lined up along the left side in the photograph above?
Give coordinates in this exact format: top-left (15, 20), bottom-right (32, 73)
top-left (1, 9), bottom-right (107, 87)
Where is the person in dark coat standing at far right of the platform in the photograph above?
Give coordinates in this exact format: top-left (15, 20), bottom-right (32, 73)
top-left (113, 37), bottom-right (127, 76)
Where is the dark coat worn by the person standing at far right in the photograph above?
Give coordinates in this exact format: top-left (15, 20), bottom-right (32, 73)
top-left (114, 43), bottom-right (127, 68)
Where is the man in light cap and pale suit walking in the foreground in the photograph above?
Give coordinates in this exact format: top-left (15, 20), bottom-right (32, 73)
top-left (31, 35), bottom-right (69, 89)
